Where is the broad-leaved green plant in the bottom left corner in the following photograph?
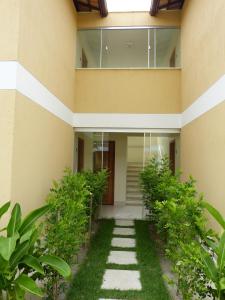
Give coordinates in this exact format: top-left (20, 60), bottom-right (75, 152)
top-left (0, 202), bottom-right (71, 300)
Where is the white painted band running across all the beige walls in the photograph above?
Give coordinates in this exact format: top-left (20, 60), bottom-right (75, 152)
top-left (0, 61), bottom-right (225, 132)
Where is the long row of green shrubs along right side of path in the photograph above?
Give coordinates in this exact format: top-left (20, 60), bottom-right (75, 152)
top-left (141, 157), bottom-right (215, 300)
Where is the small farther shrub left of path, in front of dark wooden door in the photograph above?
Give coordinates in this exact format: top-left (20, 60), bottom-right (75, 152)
top-left (83, 170), bottom-right (108, 215)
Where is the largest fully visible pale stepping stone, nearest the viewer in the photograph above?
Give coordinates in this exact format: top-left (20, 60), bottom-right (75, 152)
top-left (101, 270), bottom-right (142, 291)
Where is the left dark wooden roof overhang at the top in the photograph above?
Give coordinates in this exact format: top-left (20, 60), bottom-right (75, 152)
top-left (73, 0), bottom-right (108, 17)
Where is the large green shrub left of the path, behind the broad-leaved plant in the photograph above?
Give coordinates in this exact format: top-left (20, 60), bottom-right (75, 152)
top-left (44, 169), bottom-right (91, 299)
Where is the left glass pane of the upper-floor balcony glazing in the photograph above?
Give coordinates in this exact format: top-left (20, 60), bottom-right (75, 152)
top-left (76, 30), bottom-right (101, 68)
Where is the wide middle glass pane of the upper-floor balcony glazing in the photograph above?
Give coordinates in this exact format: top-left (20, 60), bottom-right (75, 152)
top-left (102, 29), bottom-right (148, 68)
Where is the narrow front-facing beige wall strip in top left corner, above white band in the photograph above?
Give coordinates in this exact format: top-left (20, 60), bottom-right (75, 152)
top-left (0, 0), bottom-right (20, 61)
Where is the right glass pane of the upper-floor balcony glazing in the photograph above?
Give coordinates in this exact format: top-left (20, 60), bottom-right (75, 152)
top-left (156, 29), bottom-right (180, 68)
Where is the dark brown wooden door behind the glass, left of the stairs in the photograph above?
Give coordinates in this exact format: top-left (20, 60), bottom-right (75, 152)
top-left (94, 141), bottom-right (115, 205)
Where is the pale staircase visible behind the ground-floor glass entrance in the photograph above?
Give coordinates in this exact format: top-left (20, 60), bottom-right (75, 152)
top-left (126, 163), bottom-right (143, 206)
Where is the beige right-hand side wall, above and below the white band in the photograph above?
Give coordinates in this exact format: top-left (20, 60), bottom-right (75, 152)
top-left (181, 0), bottom-right (225, 228)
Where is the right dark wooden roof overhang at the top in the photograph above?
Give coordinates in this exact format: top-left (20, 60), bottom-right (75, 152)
top-left (150, 0), bottom-right (185, 16)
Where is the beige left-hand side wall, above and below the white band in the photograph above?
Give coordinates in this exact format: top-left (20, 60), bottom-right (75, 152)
top-left (0, 0), bottom-right (76, 216)
